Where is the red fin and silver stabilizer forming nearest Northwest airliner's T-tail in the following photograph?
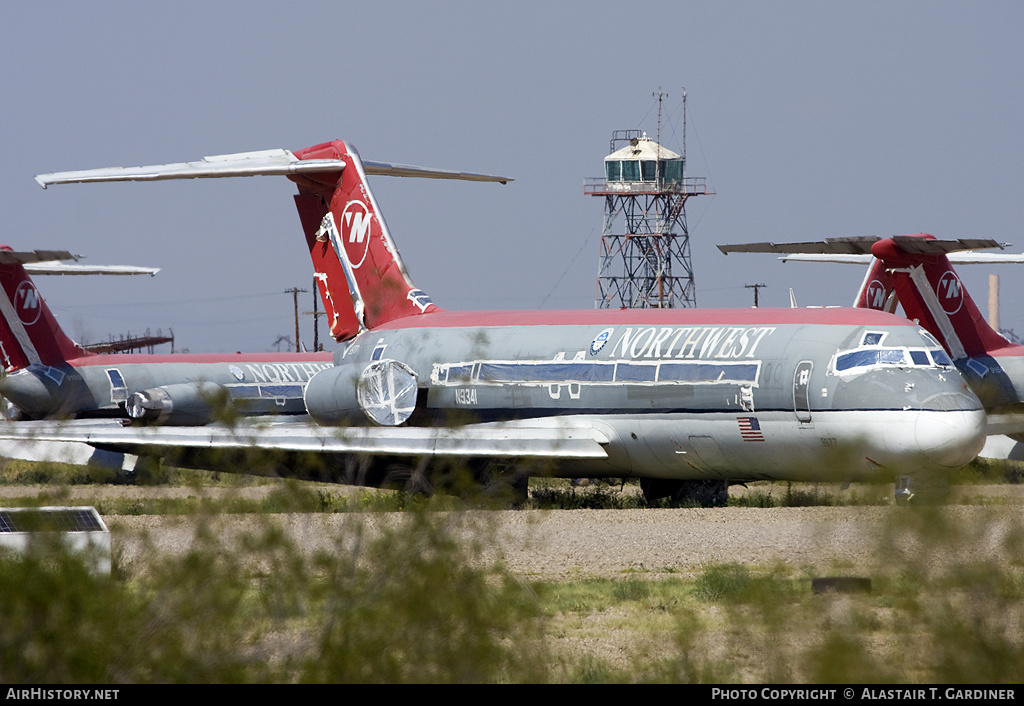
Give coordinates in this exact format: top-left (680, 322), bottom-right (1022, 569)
top-left (36, 140), bottom-right (512, 341)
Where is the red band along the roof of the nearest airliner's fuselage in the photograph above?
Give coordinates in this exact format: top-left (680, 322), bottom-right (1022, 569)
top-left (374, 307), bottom-right (916, 331)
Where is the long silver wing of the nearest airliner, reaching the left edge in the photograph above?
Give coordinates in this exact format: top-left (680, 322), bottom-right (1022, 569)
top-left (0, 416), bottom-right (610, 459)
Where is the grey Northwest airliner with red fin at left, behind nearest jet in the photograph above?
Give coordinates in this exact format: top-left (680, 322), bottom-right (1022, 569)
top-left (0, 248), bottom-right (332, 424)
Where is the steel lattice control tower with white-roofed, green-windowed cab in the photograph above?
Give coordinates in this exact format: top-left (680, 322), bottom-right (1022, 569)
top-left (584, 102), bottom-right (713, 308)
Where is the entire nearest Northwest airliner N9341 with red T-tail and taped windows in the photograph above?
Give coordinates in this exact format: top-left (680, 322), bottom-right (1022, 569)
top-left (2, 145), bottom-right (985, 504)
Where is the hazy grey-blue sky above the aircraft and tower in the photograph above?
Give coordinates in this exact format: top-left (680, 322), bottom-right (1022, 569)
top-left (0, 0), bottom-right (1024, 351)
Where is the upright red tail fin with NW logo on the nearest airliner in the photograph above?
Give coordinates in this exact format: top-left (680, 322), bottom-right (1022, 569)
top-left (290, 140), bottom-right (438, 340)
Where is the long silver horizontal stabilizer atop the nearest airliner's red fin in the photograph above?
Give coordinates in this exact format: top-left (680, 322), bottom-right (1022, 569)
top-left (36, 150), bottom-right (512, 189)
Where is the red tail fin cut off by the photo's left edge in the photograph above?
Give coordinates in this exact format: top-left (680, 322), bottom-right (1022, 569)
top-left (0, 245), bottom-right (88, 372)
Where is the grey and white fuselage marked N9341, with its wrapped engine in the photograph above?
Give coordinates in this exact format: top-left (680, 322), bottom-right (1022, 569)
top-left (306, 309), bottom-right (985, 481)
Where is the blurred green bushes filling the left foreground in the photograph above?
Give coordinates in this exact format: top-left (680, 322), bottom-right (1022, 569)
top-left (0, 512), bottom-right (546, 683)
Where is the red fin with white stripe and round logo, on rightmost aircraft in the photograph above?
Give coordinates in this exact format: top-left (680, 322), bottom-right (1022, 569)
top-left (871, 234), bottom-right (1011, 360)
